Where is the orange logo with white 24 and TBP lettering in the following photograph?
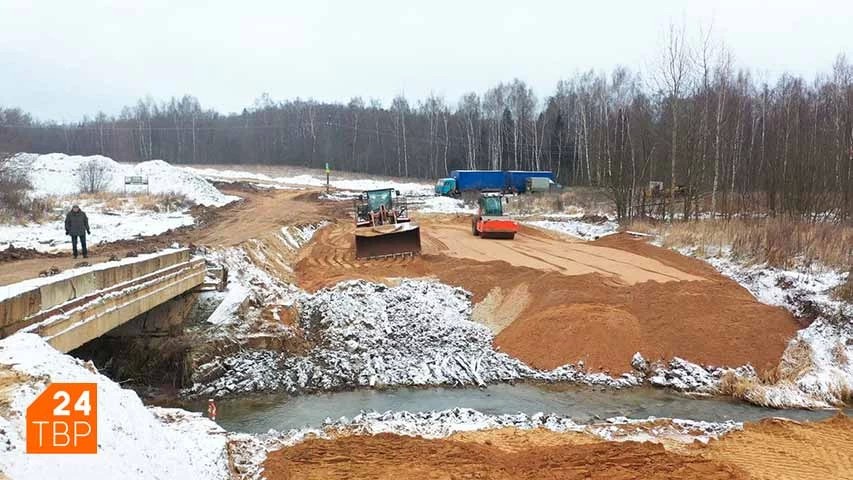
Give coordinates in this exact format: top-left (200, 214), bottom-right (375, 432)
top-left (27, 383), bottom-right (98, 453)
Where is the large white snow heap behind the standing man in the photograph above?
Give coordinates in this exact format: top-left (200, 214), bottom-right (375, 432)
top-left (10, 153), bottom-right (239, 207)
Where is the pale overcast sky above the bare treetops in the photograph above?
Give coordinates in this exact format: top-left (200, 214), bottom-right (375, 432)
top-left (0, 0), bottom-right (853, 121)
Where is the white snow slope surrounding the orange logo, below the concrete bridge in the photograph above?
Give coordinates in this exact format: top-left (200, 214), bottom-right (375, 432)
top-left (0, 333), bottom-right (231, 480)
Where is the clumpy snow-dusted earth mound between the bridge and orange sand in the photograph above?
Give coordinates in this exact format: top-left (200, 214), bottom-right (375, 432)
top-left (186, 280), bottom-right (639, 396)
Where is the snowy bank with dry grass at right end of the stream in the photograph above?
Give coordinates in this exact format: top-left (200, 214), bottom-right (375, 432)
top-left (656, 241), bottom-right (853, 408)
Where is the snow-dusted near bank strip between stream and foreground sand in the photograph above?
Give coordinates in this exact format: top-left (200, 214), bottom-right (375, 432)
top-left (231, 408), bottom-right (743, 479)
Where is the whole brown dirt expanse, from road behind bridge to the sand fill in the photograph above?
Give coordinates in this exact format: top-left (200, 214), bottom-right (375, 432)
top-left (0, 189), bottom-right (798, 374)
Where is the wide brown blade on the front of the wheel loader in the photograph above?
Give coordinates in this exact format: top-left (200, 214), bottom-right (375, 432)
top-left (355, 222), bottom-right (421, 258)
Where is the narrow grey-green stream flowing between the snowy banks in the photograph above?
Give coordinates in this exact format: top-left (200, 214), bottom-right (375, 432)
top-left (189, 385), bottom-right (834, 433)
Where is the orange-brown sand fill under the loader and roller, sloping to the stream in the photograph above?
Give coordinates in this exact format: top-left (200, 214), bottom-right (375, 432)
top-left (294, 215), bottom-right (798, 375)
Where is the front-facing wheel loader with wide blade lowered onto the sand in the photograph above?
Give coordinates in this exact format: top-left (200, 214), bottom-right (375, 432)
top-left (354, 188), bottom-right (421, 258)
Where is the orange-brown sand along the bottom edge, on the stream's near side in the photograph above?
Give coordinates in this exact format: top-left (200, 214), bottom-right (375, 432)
top-left (264, 416), bottom-right (853, 480)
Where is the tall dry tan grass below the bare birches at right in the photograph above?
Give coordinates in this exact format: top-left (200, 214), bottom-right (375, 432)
top-left (629, 218), bottom-right (853, 270)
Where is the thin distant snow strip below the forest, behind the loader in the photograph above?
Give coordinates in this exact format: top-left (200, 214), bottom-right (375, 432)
top-left (184, 167), bottom-right (433, 197)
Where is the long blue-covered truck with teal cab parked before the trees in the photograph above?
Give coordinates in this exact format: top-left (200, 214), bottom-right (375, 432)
top-left (435, 170), bottom-right (554, 196)
